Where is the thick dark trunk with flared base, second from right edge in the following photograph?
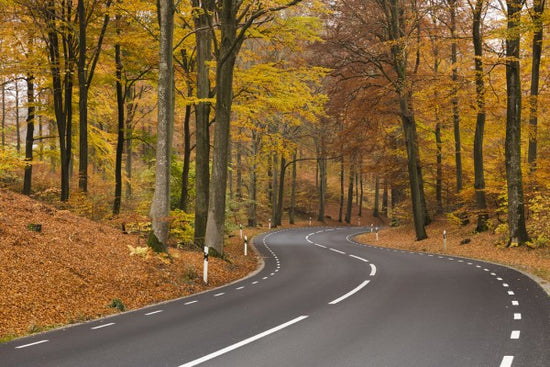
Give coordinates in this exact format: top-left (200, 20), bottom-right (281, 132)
top-left (505, 0), bottom-right (529, 244)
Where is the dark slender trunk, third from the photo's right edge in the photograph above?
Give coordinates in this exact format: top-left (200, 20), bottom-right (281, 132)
top-left (472, 0), bottom-right (489, 232)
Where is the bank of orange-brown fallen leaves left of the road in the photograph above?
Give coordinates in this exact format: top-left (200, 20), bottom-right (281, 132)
top-left (0, 190), bottom-right (258, 340)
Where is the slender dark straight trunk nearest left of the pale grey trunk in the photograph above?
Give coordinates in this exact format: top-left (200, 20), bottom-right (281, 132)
top-left (113, 14), bottom-right (124, 215)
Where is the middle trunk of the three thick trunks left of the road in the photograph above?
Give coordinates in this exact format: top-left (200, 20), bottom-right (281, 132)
top-left (193, 0), bottom-right (214, 247)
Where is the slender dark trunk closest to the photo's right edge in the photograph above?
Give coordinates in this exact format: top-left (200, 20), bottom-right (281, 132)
top-left (527, 0), bottom-right (546, 172)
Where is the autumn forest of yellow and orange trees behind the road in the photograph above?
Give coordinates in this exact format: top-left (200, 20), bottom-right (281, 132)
top-left (0, 0), bottom-right (550, 255)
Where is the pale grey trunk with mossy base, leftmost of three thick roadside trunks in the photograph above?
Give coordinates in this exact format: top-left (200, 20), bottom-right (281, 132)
top-left (148, 0), bottom-right (175, 252)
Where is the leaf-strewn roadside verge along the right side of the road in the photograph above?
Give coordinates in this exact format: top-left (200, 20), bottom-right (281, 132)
top-left (356, 218), bottom-right (550, 294)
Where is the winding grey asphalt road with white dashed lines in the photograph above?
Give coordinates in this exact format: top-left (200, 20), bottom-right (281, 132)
top-left (0, 228), bottom-right (550, 367)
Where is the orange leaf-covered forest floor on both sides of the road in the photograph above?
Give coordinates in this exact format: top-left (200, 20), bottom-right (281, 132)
top-left (0, 189), bottom-right (550, 342)
